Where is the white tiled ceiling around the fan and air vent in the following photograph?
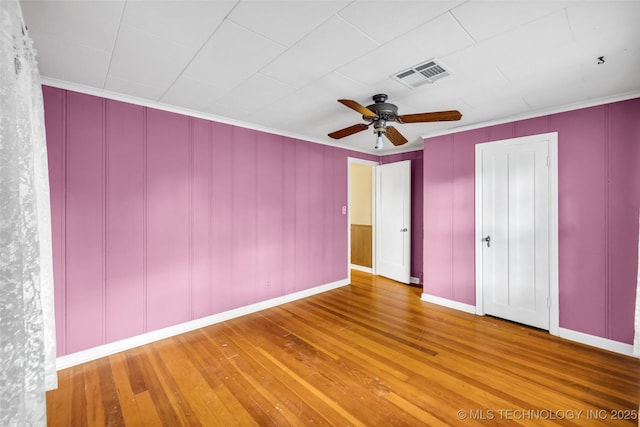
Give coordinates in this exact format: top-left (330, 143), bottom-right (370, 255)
top-left (21, 0), bottom-right (640, 154)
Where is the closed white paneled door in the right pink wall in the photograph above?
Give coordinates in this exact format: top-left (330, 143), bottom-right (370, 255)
top-left (476, 136), bottom-right (551, 330)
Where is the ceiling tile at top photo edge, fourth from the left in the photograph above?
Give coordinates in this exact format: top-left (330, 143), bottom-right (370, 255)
top-left (339, 0), bottom-right (462, 44)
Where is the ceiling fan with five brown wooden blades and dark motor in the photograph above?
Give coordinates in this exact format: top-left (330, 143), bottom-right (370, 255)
top-left (329, 93), bottom-right (462, 150)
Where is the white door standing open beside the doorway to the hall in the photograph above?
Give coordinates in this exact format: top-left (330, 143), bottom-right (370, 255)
top-left (375, 160), bottom-right (411, 283)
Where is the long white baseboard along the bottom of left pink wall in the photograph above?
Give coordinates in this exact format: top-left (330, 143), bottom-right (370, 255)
top-left (56, 279), bottom-right (349, 370)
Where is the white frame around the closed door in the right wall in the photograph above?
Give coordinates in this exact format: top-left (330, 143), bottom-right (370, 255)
top-left (475, 132), bottom-right (560, 335)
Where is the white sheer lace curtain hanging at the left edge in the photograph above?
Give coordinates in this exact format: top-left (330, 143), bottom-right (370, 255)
top-left (0, 0), bottom-right (57, 426)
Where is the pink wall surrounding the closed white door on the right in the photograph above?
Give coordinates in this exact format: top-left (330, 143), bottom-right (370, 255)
top-left (423, 99), bottom-right (640, 344)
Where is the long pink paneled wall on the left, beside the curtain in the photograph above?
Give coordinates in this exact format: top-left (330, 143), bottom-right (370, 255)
top-left (43, 87), bottom-right (363, 356)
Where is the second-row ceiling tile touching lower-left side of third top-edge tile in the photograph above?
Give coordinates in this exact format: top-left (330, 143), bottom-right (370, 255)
top-left (184, 20), bottom-right (284, 88)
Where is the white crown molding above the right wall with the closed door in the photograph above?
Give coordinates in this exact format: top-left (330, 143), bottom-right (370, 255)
top-left (422, 91), bottom-right (640, 139)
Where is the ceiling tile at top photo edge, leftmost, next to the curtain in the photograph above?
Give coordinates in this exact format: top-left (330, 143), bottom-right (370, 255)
top-left (20, 0), bottom-right (124, 51)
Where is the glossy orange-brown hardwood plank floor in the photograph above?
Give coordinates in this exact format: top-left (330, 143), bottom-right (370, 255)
top-left (47, 271), bottom-right (640, 426)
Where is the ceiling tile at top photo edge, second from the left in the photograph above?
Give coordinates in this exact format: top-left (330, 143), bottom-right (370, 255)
top-left (122, 0), bottom-right (237, 48)
